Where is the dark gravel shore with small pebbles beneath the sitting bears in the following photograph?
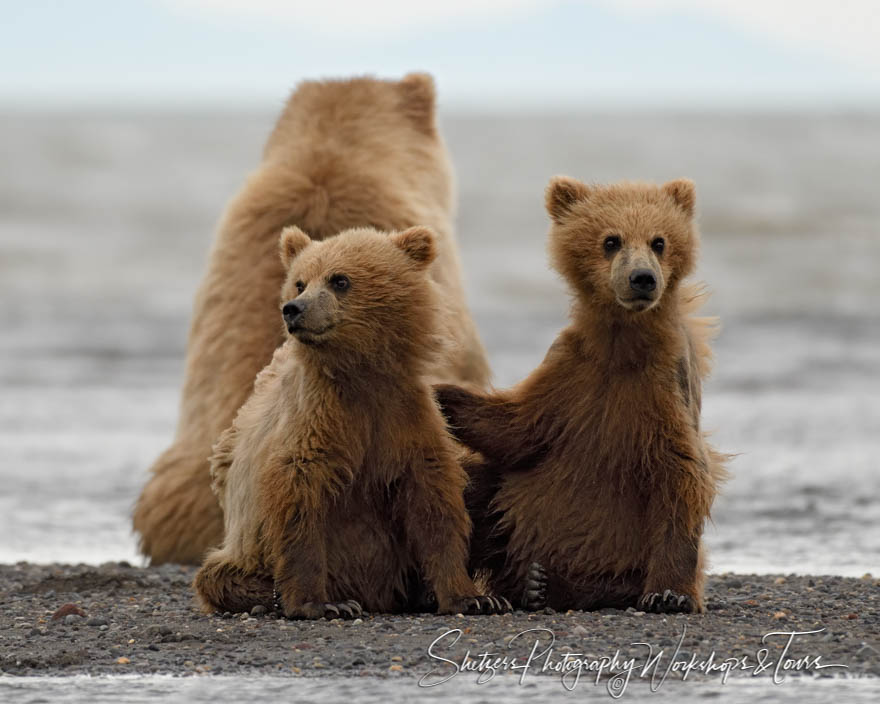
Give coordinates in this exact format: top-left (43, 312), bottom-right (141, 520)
top-left (0, 562), bottom-right (880, 681)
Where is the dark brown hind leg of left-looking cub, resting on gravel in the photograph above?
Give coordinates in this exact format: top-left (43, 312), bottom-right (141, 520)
top-left (193, 550), bottom-right (274, 613)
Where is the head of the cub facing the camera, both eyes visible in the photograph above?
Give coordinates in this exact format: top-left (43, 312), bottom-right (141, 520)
top-left (546, 176), bottom-right (698, 313)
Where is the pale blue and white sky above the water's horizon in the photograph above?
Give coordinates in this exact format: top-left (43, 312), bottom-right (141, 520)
top-left (0, 0), bottom-right (880, 110)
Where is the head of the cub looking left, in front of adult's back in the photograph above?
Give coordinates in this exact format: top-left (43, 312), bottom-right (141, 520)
top-left (280, 227), bottom-right (436, 360)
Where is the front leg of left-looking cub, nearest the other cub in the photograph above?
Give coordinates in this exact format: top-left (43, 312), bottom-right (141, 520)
top-left (395, 451), bottom-right (510, 614)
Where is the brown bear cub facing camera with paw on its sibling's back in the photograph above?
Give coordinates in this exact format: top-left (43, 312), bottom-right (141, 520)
top-left (436, 178), bottom-right (725, 612)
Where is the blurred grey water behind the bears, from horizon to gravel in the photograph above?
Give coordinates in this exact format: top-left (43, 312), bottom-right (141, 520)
top-left (0, 111), bottom-right (880, 575)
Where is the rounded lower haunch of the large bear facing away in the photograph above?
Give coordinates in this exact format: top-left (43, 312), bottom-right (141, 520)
top-left (134, 444), bottom-right (223, 565)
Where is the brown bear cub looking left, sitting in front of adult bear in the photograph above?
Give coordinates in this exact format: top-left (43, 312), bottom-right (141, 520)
top-left (195, 227), bottom-right (507, 618)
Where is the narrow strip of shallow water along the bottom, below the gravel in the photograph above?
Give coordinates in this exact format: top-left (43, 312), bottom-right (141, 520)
top-left (0, 675), bottom-right (880, 704)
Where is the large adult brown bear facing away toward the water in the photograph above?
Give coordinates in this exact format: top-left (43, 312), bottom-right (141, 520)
top-left (134, 74), bottom-right (489, 564)
